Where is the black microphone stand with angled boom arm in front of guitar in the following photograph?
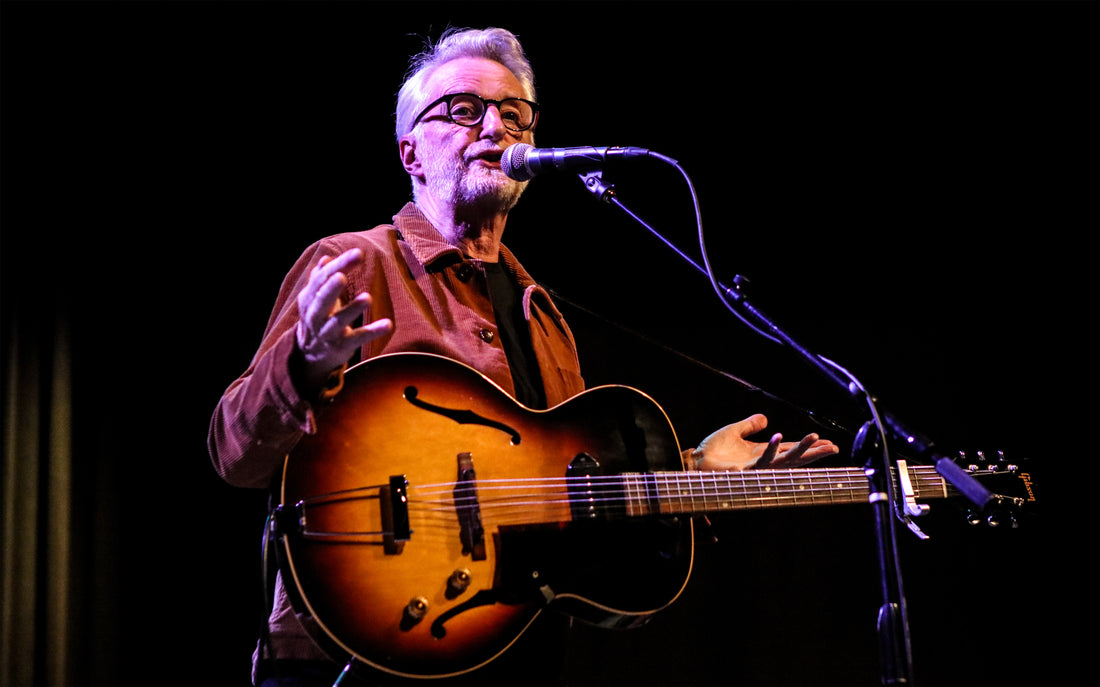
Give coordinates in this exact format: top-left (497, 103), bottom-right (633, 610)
top-left (579, 163), bottom-right (994, 685)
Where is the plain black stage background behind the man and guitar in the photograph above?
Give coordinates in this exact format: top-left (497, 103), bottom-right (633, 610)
top-left (2, 1), bottom-right (1098, 685)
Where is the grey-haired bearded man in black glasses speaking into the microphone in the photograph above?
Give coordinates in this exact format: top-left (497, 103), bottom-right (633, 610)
top-left (209, 29), bottom-right (837, 684)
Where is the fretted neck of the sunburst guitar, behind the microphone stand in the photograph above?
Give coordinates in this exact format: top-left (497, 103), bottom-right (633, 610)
top-left (622, 465), bottom-right (949, 516)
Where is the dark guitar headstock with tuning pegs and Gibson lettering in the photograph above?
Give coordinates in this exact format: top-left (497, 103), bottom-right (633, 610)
top-left (955, 451), bottom-right (1038, 529)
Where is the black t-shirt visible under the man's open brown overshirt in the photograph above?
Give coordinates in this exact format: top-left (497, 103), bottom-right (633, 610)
top-left (482, 258), bottom-right (547, 409)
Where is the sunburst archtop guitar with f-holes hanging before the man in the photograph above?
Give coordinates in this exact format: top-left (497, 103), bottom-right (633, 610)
top-left (275, 353), bottom-right (1030, 678)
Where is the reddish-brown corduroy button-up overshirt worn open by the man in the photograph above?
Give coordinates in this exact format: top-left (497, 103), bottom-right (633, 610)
top-left (208, 203), bottom-right (584, 658)
